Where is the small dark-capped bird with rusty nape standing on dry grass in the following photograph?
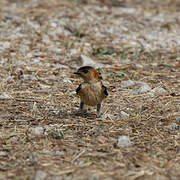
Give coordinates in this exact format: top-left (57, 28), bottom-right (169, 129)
top-left (74, 66), bottom-right (108, 117)
